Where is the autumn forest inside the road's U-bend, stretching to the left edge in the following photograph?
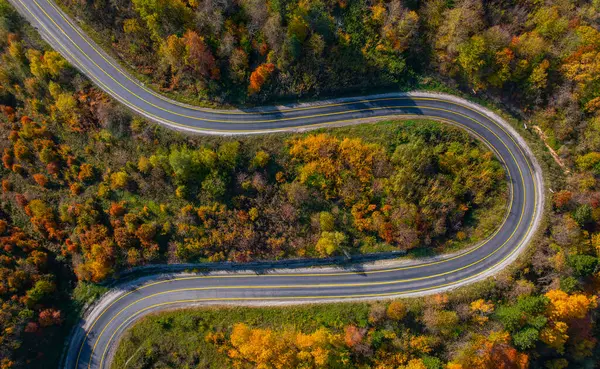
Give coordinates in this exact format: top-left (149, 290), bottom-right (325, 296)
top-left (0, 2), bottom-right (507, 368)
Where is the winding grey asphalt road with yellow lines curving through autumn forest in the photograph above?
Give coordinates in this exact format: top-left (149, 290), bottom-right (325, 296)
top-left (10, 0), bottom-right (544, 369)
